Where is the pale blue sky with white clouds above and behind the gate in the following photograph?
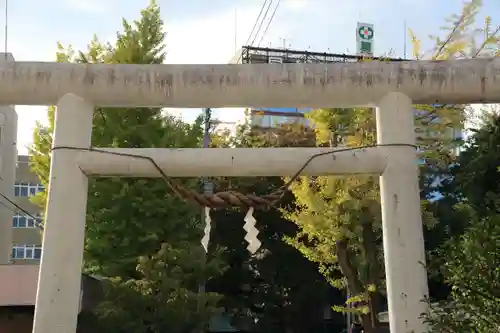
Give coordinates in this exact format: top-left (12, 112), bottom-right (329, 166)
top-left (4, 0), bottom-right (500, 154)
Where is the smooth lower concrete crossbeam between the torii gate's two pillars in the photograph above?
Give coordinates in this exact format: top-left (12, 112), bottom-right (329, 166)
top-left (77, 147), bottom-right (388, 178)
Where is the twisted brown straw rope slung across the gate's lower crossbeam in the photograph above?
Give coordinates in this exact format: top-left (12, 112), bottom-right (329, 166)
top-left (52, 143), bottom-right (418, 210)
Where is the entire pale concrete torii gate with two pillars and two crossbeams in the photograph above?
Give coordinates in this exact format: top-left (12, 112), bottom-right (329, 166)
top-left (0, 55), bottom-right (500, 333)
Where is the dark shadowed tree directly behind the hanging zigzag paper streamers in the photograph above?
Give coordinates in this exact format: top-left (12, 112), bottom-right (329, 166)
top-left (208, 124), bottom-right (343, 333)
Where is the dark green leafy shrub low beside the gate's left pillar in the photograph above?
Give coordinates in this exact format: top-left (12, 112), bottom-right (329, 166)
top-left (92, 244), bottom-right (225, 333)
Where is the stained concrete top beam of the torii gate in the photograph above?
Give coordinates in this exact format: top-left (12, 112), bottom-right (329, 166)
top-left (0, 58), bottom-right (500, 108)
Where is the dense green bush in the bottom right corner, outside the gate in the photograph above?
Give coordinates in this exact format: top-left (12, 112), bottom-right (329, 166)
top-left (428, 214), bottom-right (500, 333)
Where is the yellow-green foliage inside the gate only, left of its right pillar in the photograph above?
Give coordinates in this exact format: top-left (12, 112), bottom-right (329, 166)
top-left (285, 108), bottom-right (383, 329)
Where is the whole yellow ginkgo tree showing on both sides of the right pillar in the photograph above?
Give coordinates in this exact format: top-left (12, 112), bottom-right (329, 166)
top-left (284, 0), bottom-right (499, 332)
